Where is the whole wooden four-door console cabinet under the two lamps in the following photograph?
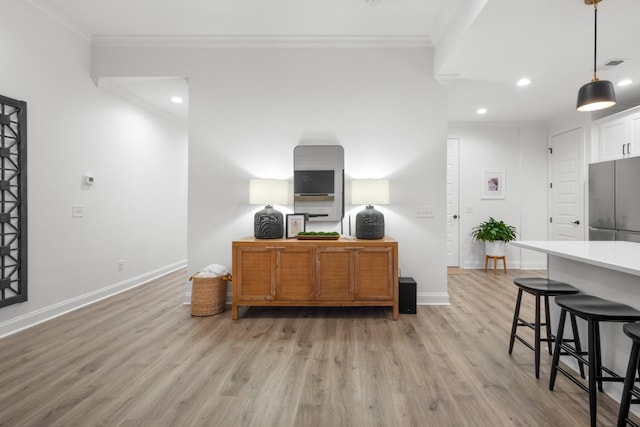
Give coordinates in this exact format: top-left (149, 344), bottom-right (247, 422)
top-left (231, 237), bottom-right (399, 320)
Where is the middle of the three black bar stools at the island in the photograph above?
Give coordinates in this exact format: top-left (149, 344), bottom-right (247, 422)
top-left (549, 294), bottom-right (640, 427)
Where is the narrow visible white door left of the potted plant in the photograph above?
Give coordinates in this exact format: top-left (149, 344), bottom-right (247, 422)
top-left (447, 138), bottom-right (460, 267)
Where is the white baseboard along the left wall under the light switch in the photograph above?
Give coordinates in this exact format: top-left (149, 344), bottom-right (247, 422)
top-left (0, 260), bottom-right (187, 338)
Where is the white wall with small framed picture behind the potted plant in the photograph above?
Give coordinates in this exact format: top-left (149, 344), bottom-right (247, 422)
top-left (449, 123), bottom-right (548, 269)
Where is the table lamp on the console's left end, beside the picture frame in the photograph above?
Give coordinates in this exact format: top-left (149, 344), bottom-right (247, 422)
top-left (249, 179), bottom-right (289, 239)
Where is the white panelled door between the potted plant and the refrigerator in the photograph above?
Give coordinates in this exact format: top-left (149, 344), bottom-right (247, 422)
top-left (549, 128), bottom-right (584, 240)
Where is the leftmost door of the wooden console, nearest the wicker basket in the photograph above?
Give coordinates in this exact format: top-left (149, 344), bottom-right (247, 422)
top-left (233, 248), bottom-right (276, 300)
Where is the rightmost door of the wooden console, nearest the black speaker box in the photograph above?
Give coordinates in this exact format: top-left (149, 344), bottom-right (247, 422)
top-left (355, 248), bottom-right (394, 301)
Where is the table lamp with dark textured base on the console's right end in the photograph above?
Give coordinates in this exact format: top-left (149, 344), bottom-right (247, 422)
top-left (351, 179), bottom-right (389, 240)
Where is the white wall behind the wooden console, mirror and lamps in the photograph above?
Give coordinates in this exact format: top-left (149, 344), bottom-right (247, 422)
top-left (92, 45), bottom-right (448, 303)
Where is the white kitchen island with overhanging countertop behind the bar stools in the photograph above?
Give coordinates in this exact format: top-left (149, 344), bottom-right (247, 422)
top-left (510, 241), bottom-right (640, 406)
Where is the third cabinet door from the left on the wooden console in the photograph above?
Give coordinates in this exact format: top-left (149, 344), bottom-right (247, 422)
top-left (316, 248), bottom-right (354, 301)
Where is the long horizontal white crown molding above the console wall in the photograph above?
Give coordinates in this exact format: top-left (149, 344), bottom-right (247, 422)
top-left (92, 36), bottom-right (433, 48)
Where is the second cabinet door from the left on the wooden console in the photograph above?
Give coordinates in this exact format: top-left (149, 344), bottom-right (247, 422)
top-left (276, 247), bottom-right (315, 301)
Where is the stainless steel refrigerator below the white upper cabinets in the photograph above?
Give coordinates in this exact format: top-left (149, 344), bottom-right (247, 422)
top-left (589, 157), bottom-right (640, 243)
